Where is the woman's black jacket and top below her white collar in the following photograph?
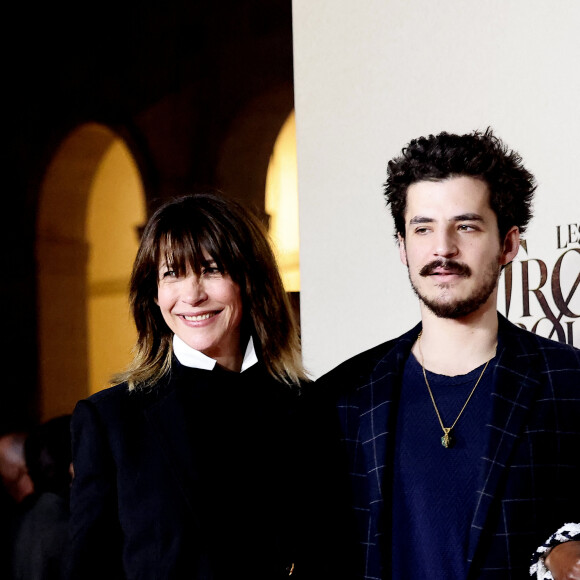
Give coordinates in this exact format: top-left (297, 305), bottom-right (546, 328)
top-left (69, 361), bottom-right (300, 580)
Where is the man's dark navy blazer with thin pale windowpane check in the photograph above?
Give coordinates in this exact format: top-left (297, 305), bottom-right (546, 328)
top-left (317, 314), bottom-right (580, 580)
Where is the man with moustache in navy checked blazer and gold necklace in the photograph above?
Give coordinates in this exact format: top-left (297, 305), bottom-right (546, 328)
top-left (318, 130), bottom-right (580, 580)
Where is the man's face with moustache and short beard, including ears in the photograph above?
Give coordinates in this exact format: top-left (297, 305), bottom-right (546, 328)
top-left (399, 176), bottom-right (519, 319)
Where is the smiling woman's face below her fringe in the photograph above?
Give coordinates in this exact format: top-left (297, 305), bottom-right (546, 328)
top-left (156, 252), bottom-right (243, 371)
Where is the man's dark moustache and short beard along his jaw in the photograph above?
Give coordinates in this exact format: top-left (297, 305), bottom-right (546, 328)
top-left (408, 255), bottom-right (501, 319)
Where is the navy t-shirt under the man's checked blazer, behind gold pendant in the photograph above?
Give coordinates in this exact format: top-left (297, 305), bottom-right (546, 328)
top-left (392, 354), bottom-right (495, 580)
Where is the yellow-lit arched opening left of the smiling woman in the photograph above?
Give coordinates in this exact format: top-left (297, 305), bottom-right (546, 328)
top-left (36, 123), bottom-right (146, 420)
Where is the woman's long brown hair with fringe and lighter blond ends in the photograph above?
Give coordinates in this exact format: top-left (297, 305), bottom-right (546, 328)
top-left (114, 194), bottom-right (306, 388)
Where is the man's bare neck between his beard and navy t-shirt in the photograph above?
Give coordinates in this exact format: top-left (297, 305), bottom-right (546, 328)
top-left (413, 302), bottom-right (498, 376)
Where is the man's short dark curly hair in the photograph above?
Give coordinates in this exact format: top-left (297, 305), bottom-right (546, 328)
top-left (385, 128), bottom-right (536, 240)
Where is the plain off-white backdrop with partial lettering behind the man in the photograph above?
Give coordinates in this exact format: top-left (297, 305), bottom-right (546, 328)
top-left (293, 0), bottom-right (580, 377)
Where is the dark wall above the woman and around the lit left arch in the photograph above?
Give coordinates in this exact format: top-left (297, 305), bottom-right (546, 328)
top-left (0, 0), bottom-right (293, 433)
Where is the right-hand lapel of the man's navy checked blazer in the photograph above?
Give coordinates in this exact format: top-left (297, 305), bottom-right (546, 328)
top-left (468, 317), bottom-right (540, 562)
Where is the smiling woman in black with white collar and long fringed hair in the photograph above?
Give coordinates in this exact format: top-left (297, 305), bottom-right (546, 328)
top-left (70, 194), bottom-right (306, 580)
